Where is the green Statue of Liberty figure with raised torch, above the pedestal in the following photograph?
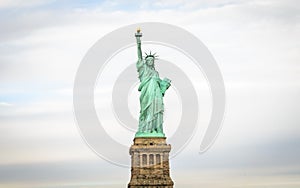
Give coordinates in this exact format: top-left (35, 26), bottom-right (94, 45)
top-left (135, 29), bottom-right (171, 137)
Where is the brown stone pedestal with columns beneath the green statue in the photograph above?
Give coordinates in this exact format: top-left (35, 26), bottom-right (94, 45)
top-left (128, 137), bottom-right (174, 188)
